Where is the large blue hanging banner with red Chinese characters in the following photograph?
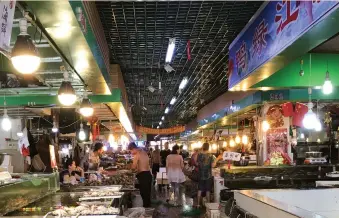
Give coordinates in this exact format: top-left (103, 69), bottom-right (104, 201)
top-left (228, 0), bottom-right (339, 89)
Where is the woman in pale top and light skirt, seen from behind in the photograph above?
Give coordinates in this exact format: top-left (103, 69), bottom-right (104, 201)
top-left (166, 145), bottom-right (185, 203)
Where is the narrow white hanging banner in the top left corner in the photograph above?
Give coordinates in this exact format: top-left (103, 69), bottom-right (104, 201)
top-left (0, 0), bottom-right (15, 54)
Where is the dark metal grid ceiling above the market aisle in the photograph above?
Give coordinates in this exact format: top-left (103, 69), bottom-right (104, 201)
top-left (96, 1), bottom-right (262, 126)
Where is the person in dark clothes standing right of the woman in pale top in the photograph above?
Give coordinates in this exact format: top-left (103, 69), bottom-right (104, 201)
top-left (197, 143), bottom-right (220, 207)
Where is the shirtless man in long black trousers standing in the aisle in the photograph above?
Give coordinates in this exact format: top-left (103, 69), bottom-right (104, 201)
top-left (128, 142), bottom-right (152, 208)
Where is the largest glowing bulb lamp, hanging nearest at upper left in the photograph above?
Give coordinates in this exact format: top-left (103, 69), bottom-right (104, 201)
top-left (11, 18), bottom-right (41, 74)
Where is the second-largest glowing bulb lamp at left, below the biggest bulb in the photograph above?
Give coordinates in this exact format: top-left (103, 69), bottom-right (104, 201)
top-left (58, 71), bottom-right (77, 106)
